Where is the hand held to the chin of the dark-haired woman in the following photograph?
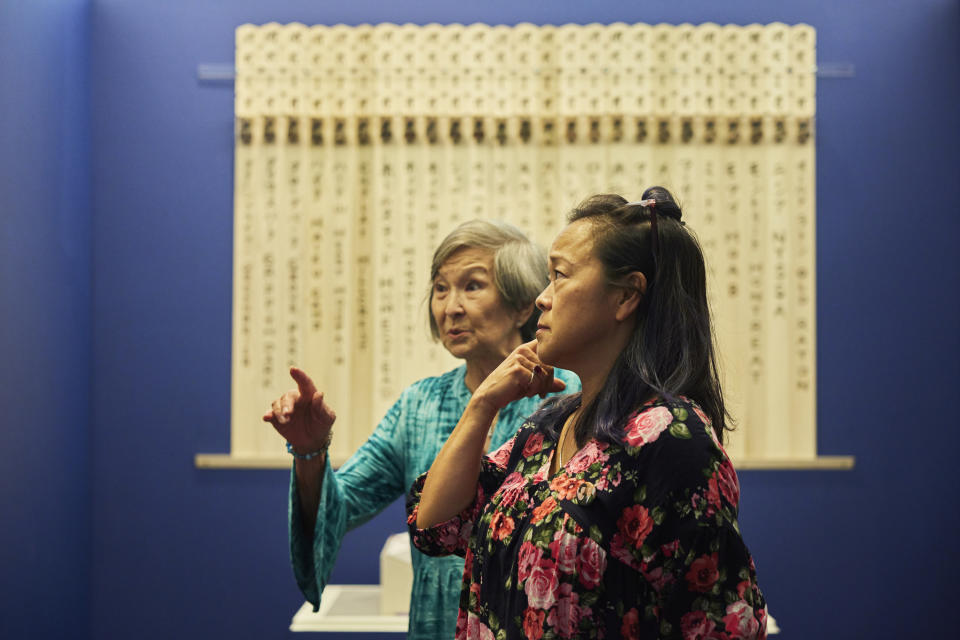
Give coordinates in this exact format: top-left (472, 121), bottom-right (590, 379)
top-left (473, 340), bottom-right (566, 410)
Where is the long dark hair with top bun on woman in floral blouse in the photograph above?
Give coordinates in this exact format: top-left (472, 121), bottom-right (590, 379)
top-left (531, 187), bottom-right (729, 446)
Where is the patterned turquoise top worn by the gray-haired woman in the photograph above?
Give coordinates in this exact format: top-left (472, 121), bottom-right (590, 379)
top-left (290, 365), bottom-right (580, 639)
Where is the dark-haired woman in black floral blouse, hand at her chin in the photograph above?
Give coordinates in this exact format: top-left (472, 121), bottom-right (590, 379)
top-left (408, 187), bottom-right (766, 640)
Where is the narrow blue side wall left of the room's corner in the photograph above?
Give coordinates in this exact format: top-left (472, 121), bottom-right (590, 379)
top-left (0, 0), bottom-right (91, 639)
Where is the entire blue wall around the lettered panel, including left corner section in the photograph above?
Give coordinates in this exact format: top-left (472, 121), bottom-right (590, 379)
top-left (0, 0), bottom-right (960, 639)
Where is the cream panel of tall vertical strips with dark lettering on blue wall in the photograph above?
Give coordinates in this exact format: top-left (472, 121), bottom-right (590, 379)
top-left (231, 24), bottom-right (816, 462)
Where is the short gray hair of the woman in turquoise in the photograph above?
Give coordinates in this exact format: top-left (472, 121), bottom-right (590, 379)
top-left (427, 220), bottom-right (549, 342)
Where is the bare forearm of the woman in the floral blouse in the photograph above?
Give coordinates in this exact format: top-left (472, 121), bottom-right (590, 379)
top-left (417, 397), bottom-right (497, 529)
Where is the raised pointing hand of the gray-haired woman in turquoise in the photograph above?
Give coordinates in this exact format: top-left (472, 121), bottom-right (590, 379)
top-left (263, 367), bottom-right (337, 454)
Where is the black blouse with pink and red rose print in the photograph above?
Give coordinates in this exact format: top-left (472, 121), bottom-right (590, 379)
top-left (407, 398), bottom-right (766, 640)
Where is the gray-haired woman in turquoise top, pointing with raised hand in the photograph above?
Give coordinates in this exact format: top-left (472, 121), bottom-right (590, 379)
top-left (263, 220), bottom-right (579, 638)
